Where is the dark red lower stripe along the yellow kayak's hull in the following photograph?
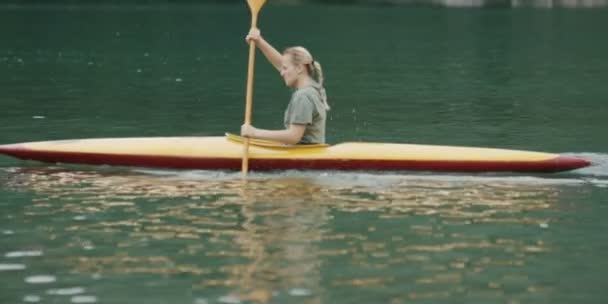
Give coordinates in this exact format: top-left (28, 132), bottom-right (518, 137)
top-left (0, 145), bottom-right (590, 172)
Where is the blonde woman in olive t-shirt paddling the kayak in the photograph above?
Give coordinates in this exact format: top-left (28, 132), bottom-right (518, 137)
top-left (241, 29), bottom-right (329, 145)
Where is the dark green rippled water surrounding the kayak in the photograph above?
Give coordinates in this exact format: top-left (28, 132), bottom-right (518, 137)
top-left (0, 5), bottom-right (608, 304)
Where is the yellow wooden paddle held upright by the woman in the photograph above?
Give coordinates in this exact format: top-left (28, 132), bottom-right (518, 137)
top-left (241, 0), bottom-right (266, 177)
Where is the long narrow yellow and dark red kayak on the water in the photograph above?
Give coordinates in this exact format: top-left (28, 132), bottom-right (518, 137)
top-left (0, 134), bottom-right (590, 172)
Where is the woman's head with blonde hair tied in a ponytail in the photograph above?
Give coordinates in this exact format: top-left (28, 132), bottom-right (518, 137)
top-left (281, 46), bottom-right (329, 110)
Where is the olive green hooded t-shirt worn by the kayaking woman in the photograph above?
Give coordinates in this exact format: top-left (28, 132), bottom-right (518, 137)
top-left (284, 86), bottom-right (327, 144)
